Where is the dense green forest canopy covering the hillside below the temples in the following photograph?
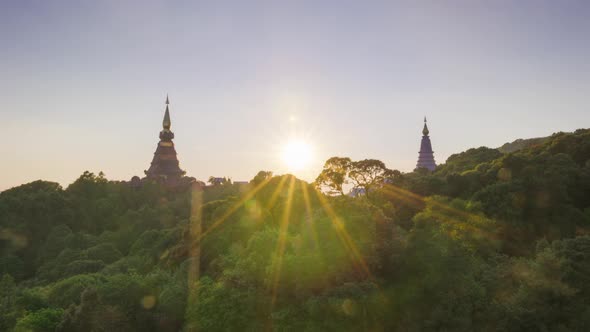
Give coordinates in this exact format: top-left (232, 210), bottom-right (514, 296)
top-left (0, 130), bottom-right (590, 331)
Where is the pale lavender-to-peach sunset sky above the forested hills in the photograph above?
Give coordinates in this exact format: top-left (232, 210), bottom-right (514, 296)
top-left (0, 0), bottom-right (590, 190)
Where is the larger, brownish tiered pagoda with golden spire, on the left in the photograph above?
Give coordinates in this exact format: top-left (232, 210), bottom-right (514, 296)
top-left (145, 96), bottom-right (186, 185)
